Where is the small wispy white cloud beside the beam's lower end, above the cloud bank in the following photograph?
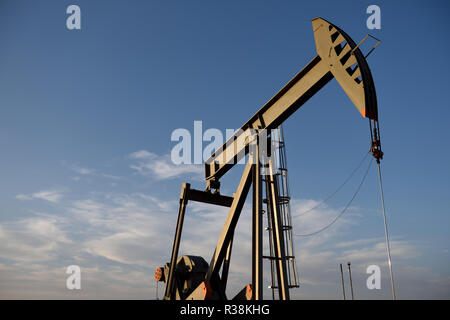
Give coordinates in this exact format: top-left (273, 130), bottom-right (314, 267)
top-left (129, 150), bottom-right (202, 180)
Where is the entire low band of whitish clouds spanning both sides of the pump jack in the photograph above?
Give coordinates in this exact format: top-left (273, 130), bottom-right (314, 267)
top-left (0, 191), bottom-right (450, 299)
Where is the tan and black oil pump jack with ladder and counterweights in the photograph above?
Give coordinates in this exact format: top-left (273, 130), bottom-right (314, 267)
top-left (155, 18), bottom-right (383, 300)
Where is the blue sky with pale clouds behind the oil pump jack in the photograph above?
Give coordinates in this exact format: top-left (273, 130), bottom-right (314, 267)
top-left (0, 0), bottom-right (450, 299)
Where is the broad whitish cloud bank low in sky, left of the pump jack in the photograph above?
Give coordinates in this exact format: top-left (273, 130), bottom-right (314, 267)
top-left (0, 194), bottom-right (177, 299)
